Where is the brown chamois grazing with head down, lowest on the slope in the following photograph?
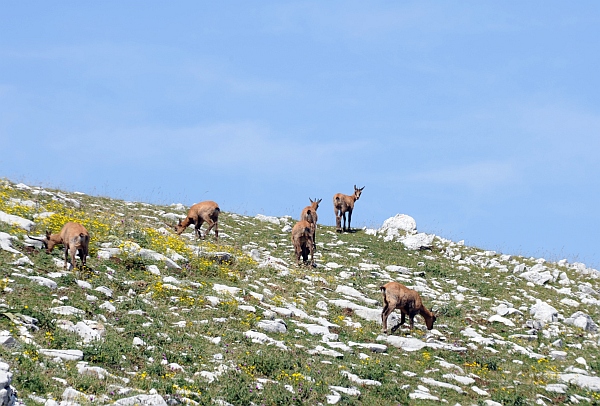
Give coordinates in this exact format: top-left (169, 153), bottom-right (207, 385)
top-left (379, 282), bottom-right (436, 334)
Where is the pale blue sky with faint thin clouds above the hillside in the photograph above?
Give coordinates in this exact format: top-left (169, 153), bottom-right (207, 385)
top-left (0, 1), bottom-right (600, 267)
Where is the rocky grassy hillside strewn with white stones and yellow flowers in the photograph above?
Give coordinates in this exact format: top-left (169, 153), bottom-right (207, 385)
top-left (0, 180), bottom-right (600, 405)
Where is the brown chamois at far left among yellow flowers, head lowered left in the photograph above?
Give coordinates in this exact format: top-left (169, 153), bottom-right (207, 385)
top-left (27, 221), bottom-right (90, 269)
